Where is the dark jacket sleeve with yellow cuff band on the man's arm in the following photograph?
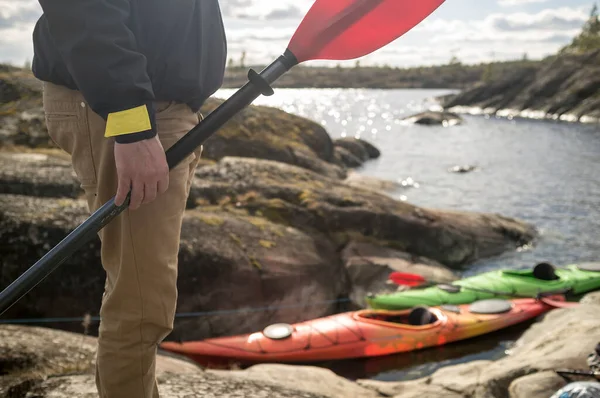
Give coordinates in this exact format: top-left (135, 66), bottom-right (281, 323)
top-left (39, 0), bottom-right (156, 143)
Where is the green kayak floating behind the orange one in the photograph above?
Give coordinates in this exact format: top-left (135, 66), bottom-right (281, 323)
top-left (366, 263), bottom-right (600, 310)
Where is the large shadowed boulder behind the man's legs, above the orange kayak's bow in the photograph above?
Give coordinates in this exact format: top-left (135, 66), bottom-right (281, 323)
top-left (0, 195), bottom-right (349, 339)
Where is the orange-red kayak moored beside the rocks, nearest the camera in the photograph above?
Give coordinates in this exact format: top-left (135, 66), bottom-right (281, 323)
top-left (161, 296), bottom-right (564, 363)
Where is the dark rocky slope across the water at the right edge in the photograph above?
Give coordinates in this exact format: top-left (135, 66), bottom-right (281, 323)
top-left (439, 50), bottom-right (600, 124)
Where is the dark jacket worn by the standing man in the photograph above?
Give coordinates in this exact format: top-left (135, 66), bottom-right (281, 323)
top-left (33, 0), bottom-right (227, 142)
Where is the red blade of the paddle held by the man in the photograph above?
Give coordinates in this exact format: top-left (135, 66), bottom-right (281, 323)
top-left (288, 0), bottom-right (444, 63)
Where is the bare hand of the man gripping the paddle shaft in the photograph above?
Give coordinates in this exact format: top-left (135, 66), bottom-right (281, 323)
top-left (115, 136), bottom-right (169, 210)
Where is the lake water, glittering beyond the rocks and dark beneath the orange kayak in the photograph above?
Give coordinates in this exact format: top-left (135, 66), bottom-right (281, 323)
top-left (217, 89), bottom-right (600, 380)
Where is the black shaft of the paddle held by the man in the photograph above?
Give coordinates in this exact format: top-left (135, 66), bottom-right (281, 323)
top-left (0, 51), bottom-right (298, 315)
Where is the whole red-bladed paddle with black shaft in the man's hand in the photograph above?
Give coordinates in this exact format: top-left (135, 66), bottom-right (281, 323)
top-left (0, 0), bottom-right (444, 315)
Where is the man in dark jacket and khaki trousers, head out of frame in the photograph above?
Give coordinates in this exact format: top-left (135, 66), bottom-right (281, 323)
top-left (33, 0), bottom-right (227, 398)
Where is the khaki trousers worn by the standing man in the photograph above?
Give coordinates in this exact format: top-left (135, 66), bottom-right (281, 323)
top-left (43, 83), bottom-right (202, 398)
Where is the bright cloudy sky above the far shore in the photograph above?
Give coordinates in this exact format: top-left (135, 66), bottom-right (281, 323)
top-left (0, 0), bottom-right (594, 67)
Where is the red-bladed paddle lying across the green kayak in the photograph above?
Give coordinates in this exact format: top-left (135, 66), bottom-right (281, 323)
top-left (389, 271), bottom-right (579, 308)
